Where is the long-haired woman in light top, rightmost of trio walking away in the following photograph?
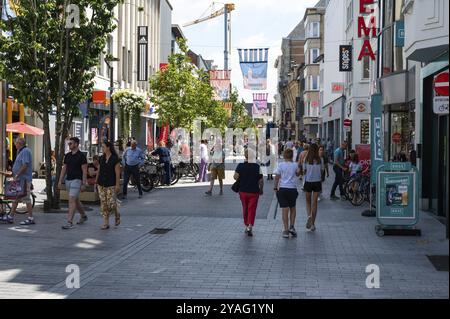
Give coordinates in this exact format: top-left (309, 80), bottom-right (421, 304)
top-left (303, 144), bottom-right (324, 231)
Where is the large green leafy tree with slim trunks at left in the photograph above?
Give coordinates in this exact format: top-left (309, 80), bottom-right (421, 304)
top-left (0, 0), bottom-right (122, 206)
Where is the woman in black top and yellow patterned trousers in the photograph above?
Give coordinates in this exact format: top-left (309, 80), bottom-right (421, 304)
top-left (95, 141), bottom-right (120, 230)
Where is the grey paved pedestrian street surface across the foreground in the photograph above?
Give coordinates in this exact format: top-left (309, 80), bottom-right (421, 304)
top-left (0, 171), bottom-right (449, 299)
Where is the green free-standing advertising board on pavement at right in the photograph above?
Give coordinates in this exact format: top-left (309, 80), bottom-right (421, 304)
top-left (375, 162), bottom-right (421, 236)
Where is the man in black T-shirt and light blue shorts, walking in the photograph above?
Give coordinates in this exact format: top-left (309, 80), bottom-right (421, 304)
top-left (58, 137), bottom-right (88, 229)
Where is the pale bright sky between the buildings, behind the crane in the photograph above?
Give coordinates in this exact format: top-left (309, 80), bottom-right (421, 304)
top-left (169, 0), bottom-right (318, 103)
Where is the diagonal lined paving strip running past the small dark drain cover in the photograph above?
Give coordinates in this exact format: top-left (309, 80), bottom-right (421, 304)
top-left (34, 217), bottom-right (187, 299)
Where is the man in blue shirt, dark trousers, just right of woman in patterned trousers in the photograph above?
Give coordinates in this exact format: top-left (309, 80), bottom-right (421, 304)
top-left (122, 140), bottom-right (145, 199)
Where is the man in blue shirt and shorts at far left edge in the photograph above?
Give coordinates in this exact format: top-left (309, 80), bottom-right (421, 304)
top-left (4, 137), bottom-right (36, 225)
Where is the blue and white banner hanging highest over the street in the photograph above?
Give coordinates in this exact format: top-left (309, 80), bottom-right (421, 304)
top-left (238, 49), bottom-right (269, 90)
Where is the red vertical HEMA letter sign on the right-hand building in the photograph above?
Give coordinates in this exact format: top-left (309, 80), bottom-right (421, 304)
top-left (358, 0), bottom-right (377, 61)
